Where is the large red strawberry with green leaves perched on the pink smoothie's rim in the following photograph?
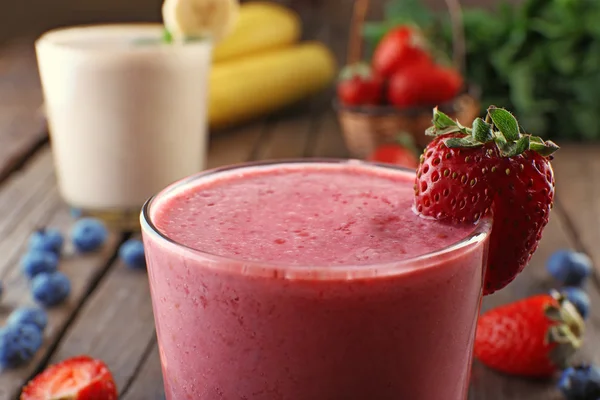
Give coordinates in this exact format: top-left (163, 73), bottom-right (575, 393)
top-left (415, 107), bottom-right (558, 294)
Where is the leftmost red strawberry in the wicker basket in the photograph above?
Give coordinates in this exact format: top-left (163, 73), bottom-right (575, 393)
top-left (337, 63), bottom-right (383, 106)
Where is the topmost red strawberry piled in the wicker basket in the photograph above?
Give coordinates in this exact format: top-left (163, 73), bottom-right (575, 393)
top-left (371, 25), bottom-right (432, 78)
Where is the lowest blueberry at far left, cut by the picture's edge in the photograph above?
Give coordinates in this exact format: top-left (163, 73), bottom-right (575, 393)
top-left (0, 324), bottom-right (42, 368)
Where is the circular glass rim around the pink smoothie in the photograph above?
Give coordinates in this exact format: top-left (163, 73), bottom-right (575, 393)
top-left (140, 158), bottom-right (492, 280)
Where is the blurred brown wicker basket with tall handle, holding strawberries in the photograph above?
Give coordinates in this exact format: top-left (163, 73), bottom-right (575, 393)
top-left (340, 0), bottom-right (480, 158)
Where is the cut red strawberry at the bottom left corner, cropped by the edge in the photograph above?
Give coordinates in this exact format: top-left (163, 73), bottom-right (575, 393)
top-left (21, 356), bottom-right (117, 400)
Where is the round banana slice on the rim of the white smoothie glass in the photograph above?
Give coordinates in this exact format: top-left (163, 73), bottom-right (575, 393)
top-left (162, 0), bottom-right (240, 42)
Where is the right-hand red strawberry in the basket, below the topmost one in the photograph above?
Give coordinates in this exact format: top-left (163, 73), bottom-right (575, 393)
top-left (387, 63), bottom-right (463, 108)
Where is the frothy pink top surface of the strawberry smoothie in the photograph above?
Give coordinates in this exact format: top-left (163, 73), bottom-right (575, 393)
top-left (153, 164), bottom-right (474, 266)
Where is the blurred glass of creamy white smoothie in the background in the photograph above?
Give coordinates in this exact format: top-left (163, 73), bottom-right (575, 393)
top-left (36, 23), bottom-right (212, 229)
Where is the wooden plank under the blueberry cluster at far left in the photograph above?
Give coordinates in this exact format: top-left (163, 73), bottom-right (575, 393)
top-left (0, 148), bottom-right (122, 400)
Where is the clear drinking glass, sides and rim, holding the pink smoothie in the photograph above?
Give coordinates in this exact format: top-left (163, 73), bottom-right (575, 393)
top-left (141, 160), bottom-right (491, 400)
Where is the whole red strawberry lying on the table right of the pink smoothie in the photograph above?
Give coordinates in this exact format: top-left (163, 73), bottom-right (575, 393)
top-left (474, 291), bottom-right (584, 377)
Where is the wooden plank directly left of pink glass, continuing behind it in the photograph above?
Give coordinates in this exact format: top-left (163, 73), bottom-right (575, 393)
top-left (45, 123), bottom-right (264, 400)
